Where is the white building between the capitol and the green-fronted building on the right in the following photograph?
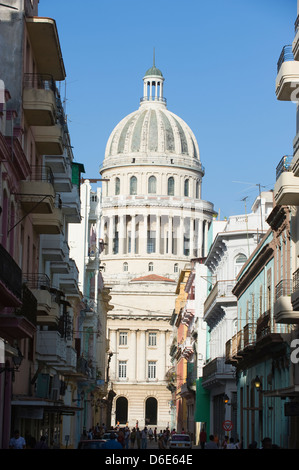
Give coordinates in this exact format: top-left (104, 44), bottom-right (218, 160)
top-left (202, 191), bottom-right (273, 439)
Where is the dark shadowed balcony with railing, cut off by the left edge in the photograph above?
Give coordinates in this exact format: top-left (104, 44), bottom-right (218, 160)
top-left (0, 244), bottom-right (22, 308)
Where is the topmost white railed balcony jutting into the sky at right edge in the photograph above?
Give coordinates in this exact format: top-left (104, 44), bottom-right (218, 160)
top-left (276, 45), bottom-right (299, 101)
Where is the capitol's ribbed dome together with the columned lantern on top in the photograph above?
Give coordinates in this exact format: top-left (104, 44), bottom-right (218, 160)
top-left (105, 65), bottom-right (200, 164)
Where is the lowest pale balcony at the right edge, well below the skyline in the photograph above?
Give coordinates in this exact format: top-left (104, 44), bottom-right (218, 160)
top-left (274, 279), bottom-right (299, 324)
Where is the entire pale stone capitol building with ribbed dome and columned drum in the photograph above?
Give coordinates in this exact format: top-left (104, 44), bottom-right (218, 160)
top-left (100, 64), bottom-right (214, 430)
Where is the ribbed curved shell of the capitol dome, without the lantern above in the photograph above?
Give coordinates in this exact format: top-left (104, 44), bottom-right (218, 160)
top-left (105, 102), bottom-right (199, 160)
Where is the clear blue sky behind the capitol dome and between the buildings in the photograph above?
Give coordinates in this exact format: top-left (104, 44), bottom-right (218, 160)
top-left (39, 0), bottom-right (297, 219)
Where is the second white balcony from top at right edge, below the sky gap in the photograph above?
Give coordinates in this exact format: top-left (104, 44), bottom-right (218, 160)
top-left (274, 156), bottom-right (299, 206)
